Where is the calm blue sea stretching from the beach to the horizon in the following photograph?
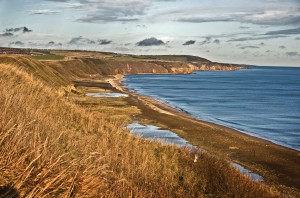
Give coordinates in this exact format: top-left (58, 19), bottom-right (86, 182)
top-left (124, 67), bottom-right (300, 151)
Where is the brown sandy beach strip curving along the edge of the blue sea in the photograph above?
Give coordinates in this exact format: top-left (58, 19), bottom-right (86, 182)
top-left (107, 74), bottom-right (300, 189)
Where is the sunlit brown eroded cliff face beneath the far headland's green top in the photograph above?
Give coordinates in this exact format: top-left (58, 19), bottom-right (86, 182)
top-left (44, 58), bottom-right (248, 80)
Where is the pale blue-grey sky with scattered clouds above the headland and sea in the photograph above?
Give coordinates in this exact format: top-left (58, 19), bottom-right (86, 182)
top-left (0, 0), bottom-right (300, 66)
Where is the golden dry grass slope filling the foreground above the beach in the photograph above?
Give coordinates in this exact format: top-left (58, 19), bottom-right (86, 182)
top-left (0, 57), bottom-right (282, 197)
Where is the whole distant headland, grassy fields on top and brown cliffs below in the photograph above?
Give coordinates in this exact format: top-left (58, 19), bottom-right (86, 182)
top-left (0, 48), bottom-right (250, 79)
